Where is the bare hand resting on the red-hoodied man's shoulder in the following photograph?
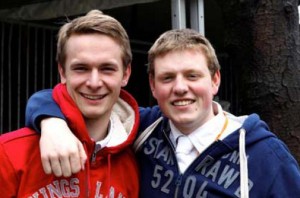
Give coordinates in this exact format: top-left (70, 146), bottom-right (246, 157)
top-left (40, 118), bottom-right (87, 177)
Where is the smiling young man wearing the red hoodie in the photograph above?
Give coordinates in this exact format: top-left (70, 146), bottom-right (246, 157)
top-left (0, 10), bottom-right (139, 198)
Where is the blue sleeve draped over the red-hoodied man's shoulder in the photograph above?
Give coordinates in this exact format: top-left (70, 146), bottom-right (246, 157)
top-left (25, 89), bottom-right (66, 132)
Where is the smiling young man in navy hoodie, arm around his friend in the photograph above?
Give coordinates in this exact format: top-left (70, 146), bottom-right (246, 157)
top-left (27, 29), bottom-right (300, 198)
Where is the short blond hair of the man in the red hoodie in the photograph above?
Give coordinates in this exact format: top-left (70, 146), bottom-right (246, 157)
top-left (56, 10), bottom-right (132, 68)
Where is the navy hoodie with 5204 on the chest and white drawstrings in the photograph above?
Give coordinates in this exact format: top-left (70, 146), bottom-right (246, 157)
top-left (26, 92), bottom-right (300, 198)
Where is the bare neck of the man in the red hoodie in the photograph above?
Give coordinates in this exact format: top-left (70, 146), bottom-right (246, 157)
top-left (85, 117), bottom-right (110, 142)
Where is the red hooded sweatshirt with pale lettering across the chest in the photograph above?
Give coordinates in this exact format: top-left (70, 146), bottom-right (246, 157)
top-left (0, 84), bottom-right (139, 198)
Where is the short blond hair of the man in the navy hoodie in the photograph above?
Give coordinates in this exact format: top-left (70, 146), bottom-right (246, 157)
top-left (148, 29), bottom-right (221, 77)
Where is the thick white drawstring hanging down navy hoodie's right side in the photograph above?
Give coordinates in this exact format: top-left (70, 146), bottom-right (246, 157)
top-left (239, 128), bottom-right (249, 198)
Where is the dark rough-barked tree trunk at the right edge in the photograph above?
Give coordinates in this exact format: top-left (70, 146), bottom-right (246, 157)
top-left (217, 0), bottom-right (300, 162)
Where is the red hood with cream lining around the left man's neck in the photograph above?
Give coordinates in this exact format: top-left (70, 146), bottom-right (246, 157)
top-left (53, 84), bottom-right (139, 153)
